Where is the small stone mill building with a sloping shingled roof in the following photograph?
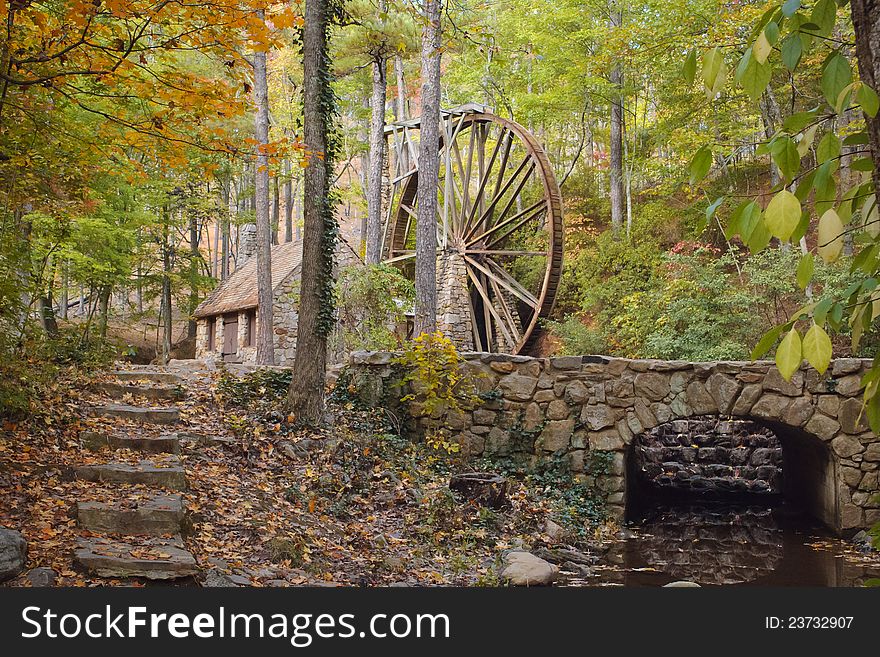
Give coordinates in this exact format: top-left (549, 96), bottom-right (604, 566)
top-left (194, 242), bottom-right (302, 365)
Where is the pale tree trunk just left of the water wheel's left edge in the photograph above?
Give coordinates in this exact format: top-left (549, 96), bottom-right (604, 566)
top-left (364, 44), bottom-right (388, 265)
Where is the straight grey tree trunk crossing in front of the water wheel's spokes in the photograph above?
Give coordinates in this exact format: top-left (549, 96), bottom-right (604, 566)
top-left (414, 0), bottom-right (442, 336)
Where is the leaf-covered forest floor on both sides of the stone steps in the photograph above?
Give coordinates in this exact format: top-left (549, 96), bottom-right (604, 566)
top-left (0, 364), bottom-right (617, 586)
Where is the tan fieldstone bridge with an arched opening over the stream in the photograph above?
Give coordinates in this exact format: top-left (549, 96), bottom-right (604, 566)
top-left (350, 352), bottom-right (880, 534)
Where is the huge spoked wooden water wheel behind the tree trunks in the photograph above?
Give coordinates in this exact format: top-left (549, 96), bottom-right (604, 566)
top-left (384, 105), bottom-right (563, 354)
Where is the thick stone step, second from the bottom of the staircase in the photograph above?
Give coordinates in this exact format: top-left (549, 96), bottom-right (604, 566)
top-left (76, 495), bottom-right (183, 536)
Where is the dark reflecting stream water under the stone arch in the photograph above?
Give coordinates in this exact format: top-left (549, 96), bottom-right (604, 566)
top-left (568, 500), bottom-right (880, 587)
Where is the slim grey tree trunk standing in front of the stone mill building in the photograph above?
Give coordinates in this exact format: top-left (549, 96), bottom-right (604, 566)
top-left (254, 10), bottom-right (275, 365)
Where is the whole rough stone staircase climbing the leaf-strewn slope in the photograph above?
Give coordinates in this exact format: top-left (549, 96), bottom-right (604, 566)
top-left (74, 368), bottom-right (199, 580)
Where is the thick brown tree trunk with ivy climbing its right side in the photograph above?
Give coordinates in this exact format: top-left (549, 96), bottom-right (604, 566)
top-left (288, 0), bottom-right (336, 425)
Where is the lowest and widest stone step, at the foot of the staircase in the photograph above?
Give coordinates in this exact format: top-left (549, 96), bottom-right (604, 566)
top-left (74, 537), bottom-right (199, 580)
